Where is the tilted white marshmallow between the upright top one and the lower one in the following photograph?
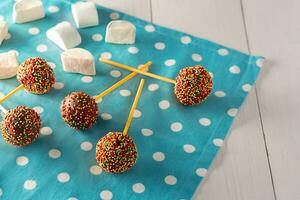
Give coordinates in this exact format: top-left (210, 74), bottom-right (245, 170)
top-left (46, 21), bottom-right (81, 50)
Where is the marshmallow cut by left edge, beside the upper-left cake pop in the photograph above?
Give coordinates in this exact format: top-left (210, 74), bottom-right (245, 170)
top-left (0, 51), bottom-right (19, 79)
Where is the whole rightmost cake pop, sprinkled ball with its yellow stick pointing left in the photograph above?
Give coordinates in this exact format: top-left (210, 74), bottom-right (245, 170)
top-left (100, 58), bottom-right (213, 106)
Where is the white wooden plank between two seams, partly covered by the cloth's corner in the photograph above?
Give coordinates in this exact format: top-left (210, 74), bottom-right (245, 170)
top-left (152, 0), bottom-right (274, 200)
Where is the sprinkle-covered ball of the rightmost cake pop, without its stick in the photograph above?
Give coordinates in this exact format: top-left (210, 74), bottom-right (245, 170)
top-left (174, 66), bottom-right (212, 106)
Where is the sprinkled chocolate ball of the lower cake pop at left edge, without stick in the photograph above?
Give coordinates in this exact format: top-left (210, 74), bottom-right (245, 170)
top-left (1, 106), bottom-right (41, 146)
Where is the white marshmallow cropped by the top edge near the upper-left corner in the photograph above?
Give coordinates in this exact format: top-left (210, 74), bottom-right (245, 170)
top-left (13, 0), bottom-right (45, 24)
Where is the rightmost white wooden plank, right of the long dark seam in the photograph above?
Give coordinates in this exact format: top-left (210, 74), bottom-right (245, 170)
top-left (243, 0), bottom-right (300, 200)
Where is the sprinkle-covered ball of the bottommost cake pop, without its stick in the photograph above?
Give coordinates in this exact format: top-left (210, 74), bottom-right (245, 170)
top-left (96, 132), bottom-right (138, 173)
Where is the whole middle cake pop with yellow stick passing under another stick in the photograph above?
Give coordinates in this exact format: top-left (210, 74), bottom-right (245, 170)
top-left (61, 62), bottom-right (152, 130)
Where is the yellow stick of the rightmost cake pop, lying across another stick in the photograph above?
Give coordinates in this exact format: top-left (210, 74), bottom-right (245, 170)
top-left (99, 58), bottom-right (176, 84)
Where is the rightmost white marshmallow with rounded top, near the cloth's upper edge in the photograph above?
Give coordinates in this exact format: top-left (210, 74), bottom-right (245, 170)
top-left (105, 20), bottom-right (136, 44)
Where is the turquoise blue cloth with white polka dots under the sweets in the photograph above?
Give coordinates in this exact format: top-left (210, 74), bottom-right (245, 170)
top-left (0, 0), bottom-right (263, 200)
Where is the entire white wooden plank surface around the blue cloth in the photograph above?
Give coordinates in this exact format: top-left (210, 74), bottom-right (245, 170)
top-left (93, 0), bottom-right (300, 200)
